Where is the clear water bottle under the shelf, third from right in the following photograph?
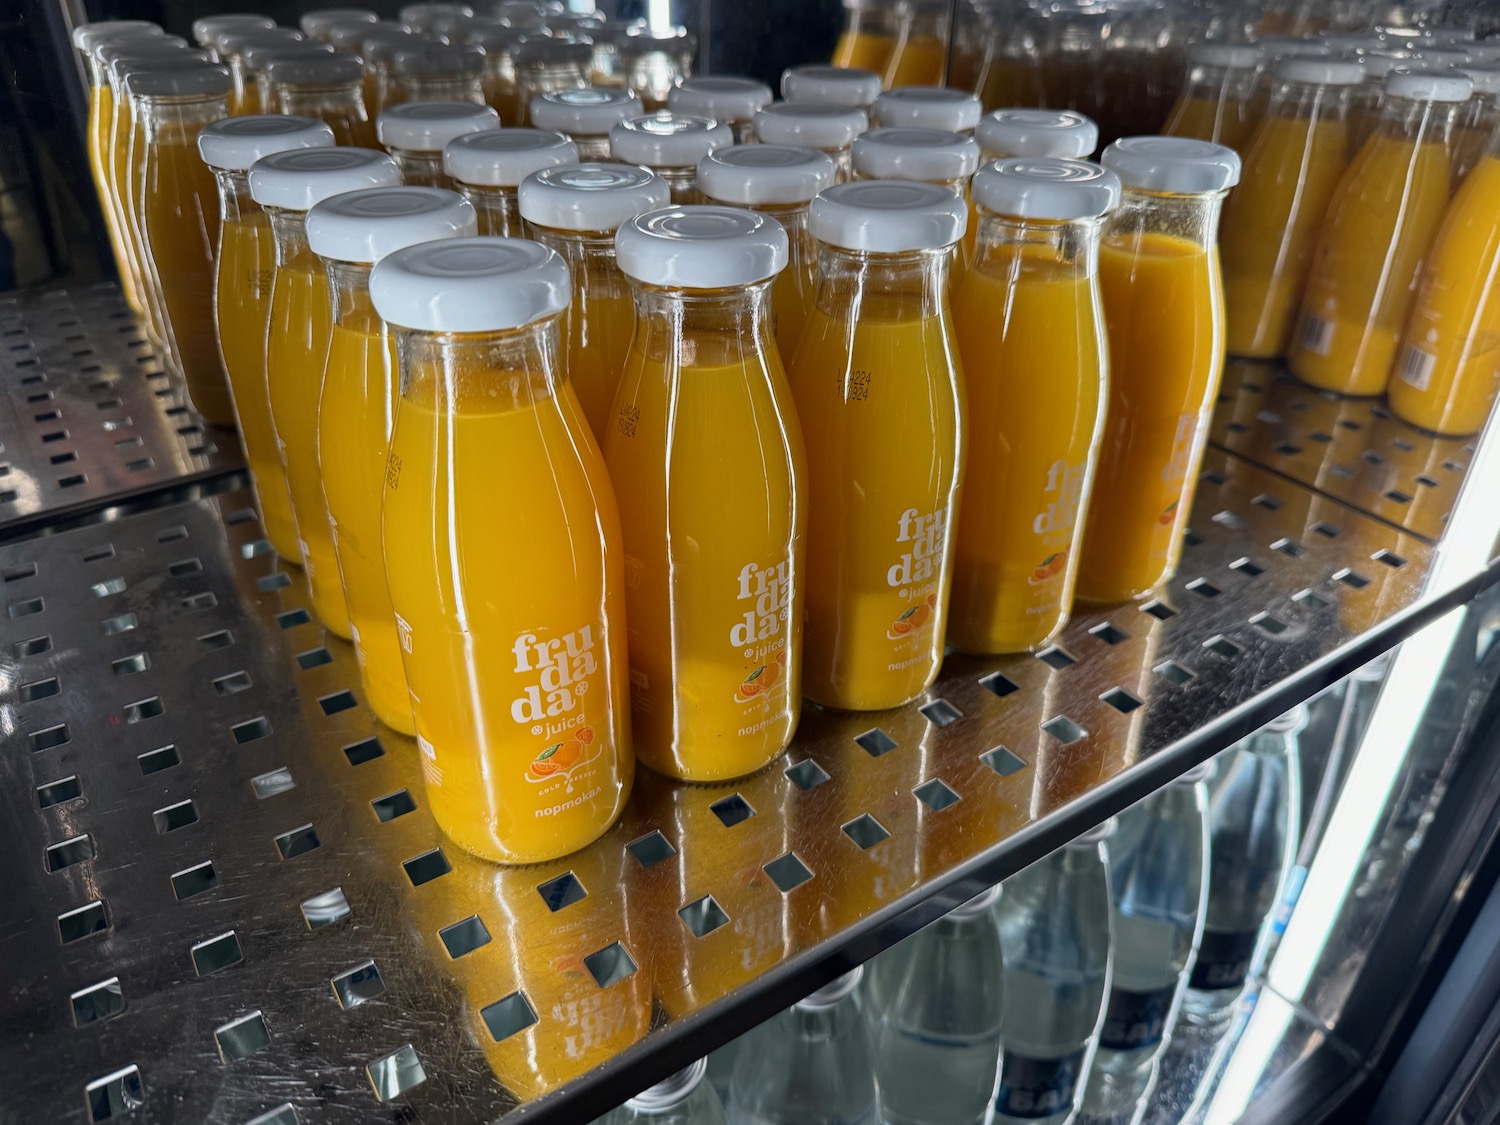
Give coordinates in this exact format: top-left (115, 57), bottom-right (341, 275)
top-left (993, 821), bottom-right (1115, 1125)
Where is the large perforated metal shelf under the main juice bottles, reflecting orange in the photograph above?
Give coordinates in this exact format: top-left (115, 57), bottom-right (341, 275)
top-left (0, 452), bottom-right (1490, 1125)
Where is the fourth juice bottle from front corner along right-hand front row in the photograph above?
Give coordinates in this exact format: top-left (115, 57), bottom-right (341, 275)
top-left (948, 156), bottom-right (1121, 653)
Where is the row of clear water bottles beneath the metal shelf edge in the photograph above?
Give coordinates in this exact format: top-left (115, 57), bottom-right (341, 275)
top-left (602, 708), bottom-right (1307, 1125)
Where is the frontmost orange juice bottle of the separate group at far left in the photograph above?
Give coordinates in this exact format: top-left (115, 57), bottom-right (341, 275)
top-left (125, 65), bottom-right (234, 426)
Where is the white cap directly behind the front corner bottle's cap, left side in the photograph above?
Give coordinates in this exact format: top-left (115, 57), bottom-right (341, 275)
top-left (308, 188), bottom-right (479, 263)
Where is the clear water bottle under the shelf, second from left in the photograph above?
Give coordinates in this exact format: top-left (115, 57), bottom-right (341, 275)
top-left (729, 966), bottom-right (876, 1125)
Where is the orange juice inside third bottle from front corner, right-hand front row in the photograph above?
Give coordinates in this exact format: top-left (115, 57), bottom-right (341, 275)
top-left (791, 300), bottom-right (963, 711)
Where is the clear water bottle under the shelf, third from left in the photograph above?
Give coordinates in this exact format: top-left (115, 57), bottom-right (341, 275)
top-left (864, 887), bottom-right (1004, 1125)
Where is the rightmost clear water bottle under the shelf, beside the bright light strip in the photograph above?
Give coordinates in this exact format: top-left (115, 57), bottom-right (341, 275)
top-left (1182, 717), bottom-right (1307, 1022)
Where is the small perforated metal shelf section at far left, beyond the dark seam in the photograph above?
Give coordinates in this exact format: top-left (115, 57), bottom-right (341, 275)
top-left (0, 282), bottom-right (243, 537)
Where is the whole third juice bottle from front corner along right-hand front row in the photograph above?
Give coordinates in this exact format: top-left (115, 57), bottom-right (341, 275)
top-left (791, 183), bottom-right (972, 711)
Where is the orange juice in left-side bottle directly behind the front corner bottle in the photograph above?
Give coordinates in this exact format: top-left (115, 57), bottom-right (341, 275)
top-left (318, 299), bottom-right (416, 735)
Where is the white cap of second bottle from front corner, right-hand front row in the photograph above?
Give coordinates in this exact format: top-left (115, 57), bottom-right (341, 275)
top-left (615, 206), bottom-right (789, 290)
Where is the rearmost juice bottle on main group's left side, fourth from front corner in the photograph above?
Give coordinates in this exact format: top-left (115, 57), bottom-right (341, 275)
top-left (198, 114), bottom-right (333, 564)
